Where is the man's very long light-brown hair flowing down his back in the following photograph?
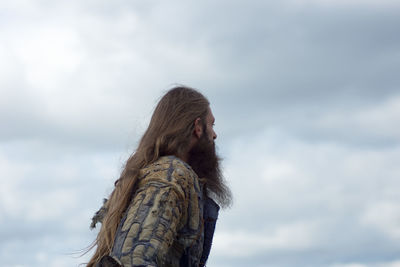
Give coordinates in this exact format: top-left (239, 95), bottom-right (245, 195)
top-left (87, 86), bottom-right (209, 267)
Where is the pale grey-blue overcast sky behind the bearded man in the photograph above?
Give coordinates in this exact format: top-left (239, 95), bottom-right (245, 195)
top-left (0, 0), bottom-right (400, 267)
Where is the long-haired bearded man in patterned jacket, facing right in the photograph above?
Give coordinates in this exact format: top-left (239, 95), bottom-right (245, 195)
top-left (87, 87), bottom-right (231, 267)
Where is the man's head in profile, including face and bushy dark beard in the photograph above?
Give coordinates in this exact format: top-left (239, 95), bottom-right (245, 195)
top-left (136, 87), bottom-right (231, 206)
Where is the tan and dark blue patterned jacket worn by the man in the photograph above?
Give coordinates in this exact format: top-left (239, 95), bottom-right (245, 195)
top-left (99, 156), bottom-right (219, 267)
